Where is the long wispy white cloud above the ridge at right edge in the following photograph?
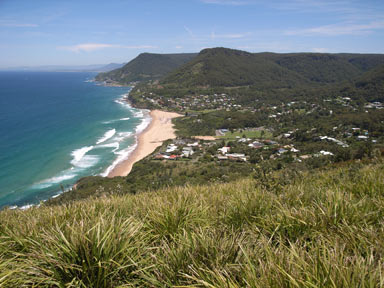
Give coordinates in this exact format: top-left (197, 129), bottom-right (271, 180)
top-left (284, 21), bottom-right (384, 36)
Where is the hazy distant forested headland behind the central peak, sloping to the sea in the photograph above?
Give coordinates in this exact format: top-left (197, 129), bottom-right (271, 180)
top-left (96, 53), bottom-right (197, 84)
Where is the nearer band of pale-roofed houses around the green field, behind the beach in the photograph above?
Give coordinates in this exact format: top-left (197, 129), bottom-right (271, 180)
top-left (151, 127), bottom-right (377, 163)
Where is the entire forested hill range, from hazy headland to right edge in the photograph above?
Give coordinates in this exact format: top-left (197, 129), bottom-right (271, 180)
top-left (96, 48), bottom-right (384, 89)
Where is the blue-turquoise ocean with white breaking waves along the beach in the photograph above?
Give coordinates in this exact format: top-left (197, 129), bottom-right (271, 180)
top-left (0, 72), bottom-right (149, 207)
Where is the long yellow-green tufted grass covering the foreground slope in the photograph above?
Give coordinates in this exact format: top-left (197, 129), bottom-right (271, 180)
top-left (0, 160), bottom-right (384, 288)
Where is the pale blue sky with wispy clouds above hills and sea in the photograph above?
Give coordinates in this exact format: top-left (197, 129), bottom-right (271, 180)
top-left (0, 0), bottom-right (384, 68)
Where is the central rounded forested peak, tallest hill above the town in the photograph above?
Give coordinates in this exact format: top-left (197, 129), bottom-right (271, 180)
top-left (162, 48), bottom-right (308, 87)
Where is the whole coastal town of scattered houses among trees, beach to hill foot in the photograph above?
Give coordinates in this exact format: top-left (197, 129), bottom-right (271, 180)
top-left (127, 82), bottom-right (383, 172)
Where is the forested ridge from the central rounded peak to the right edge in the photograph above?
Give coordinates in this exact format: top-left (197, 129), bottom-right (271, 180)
top-left (162, 48), bottom-right (384, 88)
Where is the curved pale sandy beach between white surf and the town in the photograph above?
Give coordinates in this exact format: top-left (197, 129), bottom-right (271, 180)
top-left (108, 110), bottom-right (182, 177)
